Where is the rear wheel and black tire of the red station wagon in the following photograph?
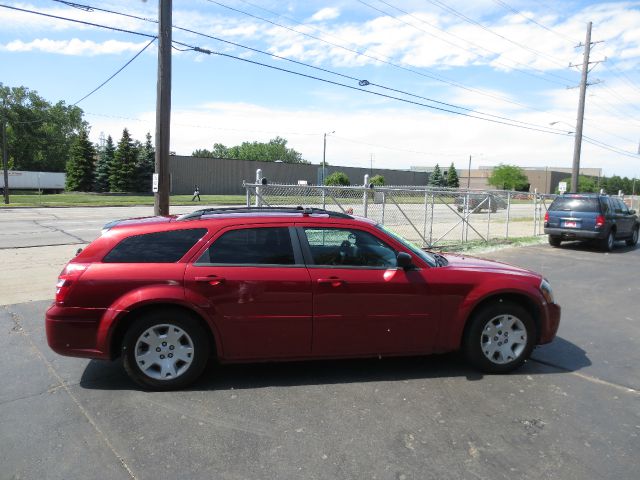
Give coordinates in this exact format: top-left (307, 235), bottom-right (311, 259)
top-left (122, 308), bottom-right (211, 391)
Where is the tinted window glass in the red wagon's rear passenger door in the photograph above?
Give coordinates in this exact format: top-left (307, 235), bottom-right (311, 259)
top-left (196, 227), bottom-right (296, 265)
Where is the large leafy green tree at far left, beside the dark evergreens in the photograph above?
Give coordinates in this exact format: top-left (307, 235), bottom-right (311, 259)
top-left (0, 83), bottom-right (88, 172)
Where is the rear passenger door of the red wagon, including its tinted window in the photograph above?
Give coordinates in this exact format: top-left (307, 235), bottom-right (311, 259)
top-left (185, 224), bottom-right (312, 359)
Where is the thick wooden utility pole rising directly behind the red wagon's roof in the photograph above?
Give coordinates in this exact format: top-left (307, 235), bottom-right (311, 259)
top-left (153, 0), bottom-right (172, 215)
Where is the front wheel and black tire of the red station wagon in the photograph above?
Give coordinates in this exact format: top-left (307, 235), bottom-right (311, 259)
top-left (463, 300), bottom-right (537, 373)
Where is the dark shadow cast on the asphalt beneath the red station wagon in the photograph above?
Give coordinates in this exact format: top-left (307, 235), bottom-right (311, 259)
top-left (80, 337), bottom-right (591, 390)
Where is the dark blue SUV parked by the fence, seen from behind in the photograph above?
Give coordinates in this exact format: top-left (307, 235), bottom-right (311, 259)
top-left (544, 193), bottom-right (640, 251)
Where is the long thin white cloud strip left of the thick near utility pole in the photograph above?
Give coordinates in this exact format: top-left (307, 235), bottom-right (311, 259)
top-left (0, 38), bottom-right (148, 57)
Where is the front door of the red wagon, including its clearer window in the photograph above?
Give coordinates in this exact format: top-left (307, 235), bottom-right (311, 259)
top-left (298, 224), bottom-right (439, 356)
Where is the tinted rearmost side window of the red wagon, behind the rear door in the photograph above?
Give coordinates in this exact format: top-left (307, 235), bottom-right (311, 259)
top-left (102, 228), bottom-right (207, 263)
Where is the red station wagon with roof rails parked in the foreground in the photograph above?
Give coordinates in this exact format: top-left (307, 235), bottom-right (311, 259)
top-left (46, 207), bottom-right (560, 390)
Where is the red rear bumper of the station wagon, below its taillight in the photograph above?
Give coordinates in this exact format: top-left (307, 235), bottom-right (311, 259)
top-left (45, 304), bottom-right (110, 360)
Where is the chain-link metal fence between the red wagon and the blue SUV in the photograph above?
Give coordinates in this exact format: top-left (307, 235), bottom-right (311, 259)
top-left (245, 175), bottom-right (555, 247)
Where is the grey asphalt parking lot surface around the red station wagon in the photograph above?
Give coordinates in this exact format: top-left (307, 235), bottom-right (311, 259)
top-left (0, 207), bottom-right (640, 480)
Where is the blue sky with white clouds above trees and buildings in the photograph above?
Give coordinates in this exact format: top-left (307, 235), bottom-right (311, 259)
top-left (0, 0), bottom-right (640, 177)
